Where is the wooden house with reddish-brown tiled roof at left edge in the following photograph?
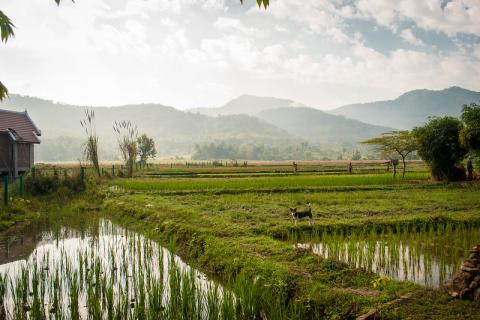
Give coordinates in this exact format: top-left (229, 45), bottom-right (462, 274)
top-left (0, 109), bottom-right (42, 175)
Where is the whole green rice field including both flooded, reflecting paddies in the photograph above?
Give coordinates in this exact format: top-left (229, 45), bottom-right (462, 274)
top-left (0, 162), bottom-right (480, 319)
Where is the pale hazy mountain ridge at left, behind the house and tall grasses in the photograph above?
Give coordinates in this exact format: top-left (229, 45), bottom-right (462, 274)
top-left (0, 94), bottom-right (294, 160)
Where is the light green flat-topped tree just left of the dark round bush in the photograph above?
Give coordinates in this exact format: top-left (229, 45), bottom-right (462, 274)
top-left (361, 131), bottom-right (417, 178)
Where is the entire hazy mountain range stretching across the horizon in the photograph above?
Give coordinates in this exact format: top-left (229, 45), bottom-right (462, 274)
top-left (0, 87), bottom-right (480, 161)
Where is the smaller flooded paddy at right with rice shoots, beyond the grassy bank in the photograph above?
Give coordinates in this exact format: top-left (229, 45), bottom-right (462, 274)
top-left (297, 226), bottom-right (480, 287)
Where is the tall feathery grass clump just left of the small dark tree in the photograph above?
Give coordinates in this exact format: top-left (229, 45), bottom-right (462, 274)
top-left (113, 121), bottom-right (138, 177)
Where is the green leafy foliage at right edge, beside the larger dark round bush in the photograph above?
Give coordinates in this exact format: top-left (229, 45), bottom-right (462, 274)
top-left (460, 103), bottom-right (480, 154)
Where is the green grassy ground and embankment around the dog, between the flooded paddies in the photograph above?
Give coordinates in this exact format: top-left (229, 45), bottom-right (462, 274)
top-left (104, 173), bottom-right (480, 319)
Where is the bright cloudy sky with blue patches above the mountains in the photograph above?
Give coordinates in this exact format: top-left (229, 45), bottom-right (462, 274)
top-left (0, 0), bottom-right (480, 109)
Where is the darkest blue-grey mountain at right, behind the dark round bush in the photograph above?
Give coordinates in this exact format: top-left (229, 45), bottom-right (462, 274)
top-left (331, 87), bottom-right (480, 129)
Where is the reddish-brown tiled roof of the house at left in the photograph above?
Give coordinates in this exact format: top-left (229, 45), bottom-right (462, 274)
top-left (0, 109), bottom-right (42, 143)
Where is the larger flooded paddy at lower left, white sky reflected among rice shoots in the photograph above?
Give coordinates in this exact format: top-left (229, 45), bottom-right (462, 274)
top-left (0, 220), bottom-right (227, 319)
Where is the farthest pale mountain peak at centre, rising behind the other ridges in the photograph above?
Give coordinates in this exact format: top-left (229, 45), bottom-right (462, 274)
top-left (190, 95), bottom-right (303, 116)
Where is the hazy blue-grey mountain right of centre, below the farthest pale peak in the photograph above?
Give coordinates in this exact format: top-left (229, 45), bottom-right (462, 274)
top-left (257, 107), bottom-right (393, 146)
